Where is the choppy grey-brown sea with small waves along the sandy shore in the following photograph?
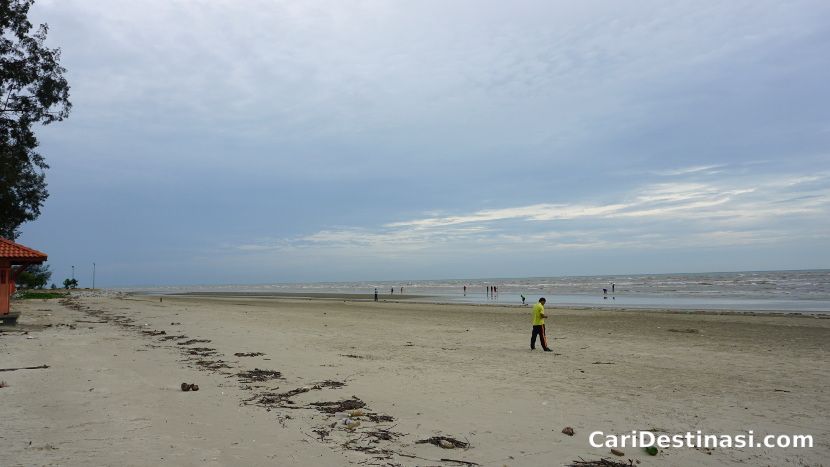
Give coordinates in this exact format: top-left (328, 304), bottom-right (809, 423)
top-left (134, 269), bottom-right (830, 314)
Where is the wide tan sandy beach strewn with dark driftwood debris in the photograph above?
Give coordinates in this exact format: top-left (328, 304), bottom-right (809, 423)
top-left (0, 292), bottom-right (830, 466)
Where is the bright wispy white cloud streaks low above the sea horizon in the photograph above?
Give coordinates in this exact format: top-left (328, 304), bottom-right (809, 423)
top-left (237, 167), bottom-right (830, 256)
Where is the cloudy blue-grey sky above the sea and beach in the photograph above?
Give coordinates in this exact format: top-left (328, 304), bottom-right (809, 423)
top-left (18, 0), bottom-right (830, 287)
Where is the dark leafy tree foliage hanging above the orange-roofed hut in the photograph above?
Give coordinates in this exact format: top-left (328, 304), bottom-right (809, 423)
top-left (0, 0), bottom-right (72, 239)
